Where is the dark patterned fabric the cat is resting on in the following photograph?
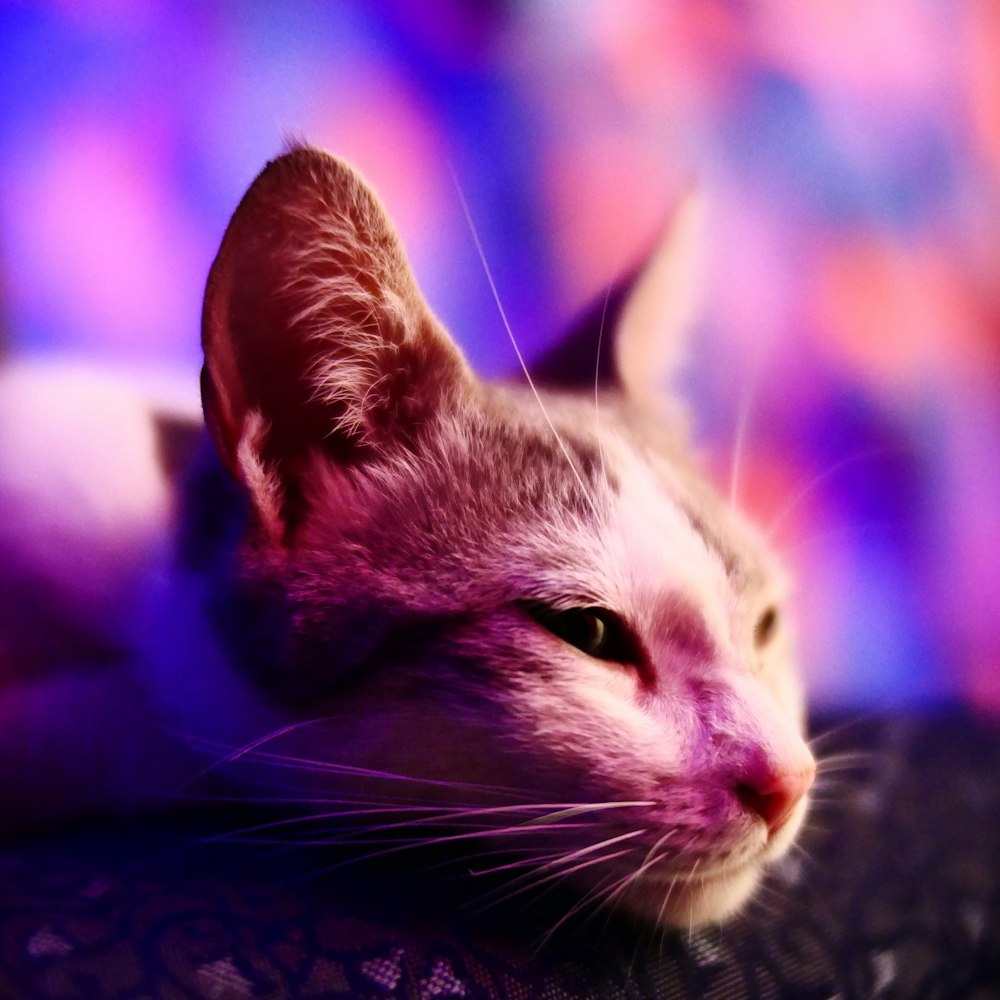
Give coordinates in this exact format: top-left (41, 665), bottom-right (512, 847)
top-left (0, 713), bottom-right (1000, 1000)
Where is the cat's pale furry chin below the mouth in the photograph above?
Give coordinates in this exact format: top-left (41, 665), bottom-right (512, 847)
top-left (623, 861), bottom-right (763, 929)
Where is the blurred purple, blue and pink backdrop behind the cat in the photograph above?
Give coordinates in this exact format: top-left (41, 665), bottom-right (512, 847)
top-left (0, 0), bottom-right (1000, 711)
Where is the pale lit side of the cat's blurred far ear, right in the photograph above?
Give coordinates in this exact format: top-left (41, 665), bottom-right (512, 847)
top-left (614, 188), bottom-right (705, 401)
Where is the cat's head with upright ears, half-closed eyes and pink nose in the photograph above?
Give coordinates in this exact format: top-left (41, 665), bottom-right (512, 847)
top-left (202, 148), bottom-right (814, 924)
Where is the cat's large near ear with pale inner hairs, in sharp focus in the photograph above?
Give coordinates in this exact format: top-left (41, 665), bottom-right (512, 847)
top-left (202, 147), bottom-right (471, 522)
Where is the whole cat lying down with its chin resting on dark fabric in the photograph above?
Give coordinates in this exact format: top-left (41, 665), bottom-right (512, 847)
top-left (0, 146), bottom-right (815, 927)
